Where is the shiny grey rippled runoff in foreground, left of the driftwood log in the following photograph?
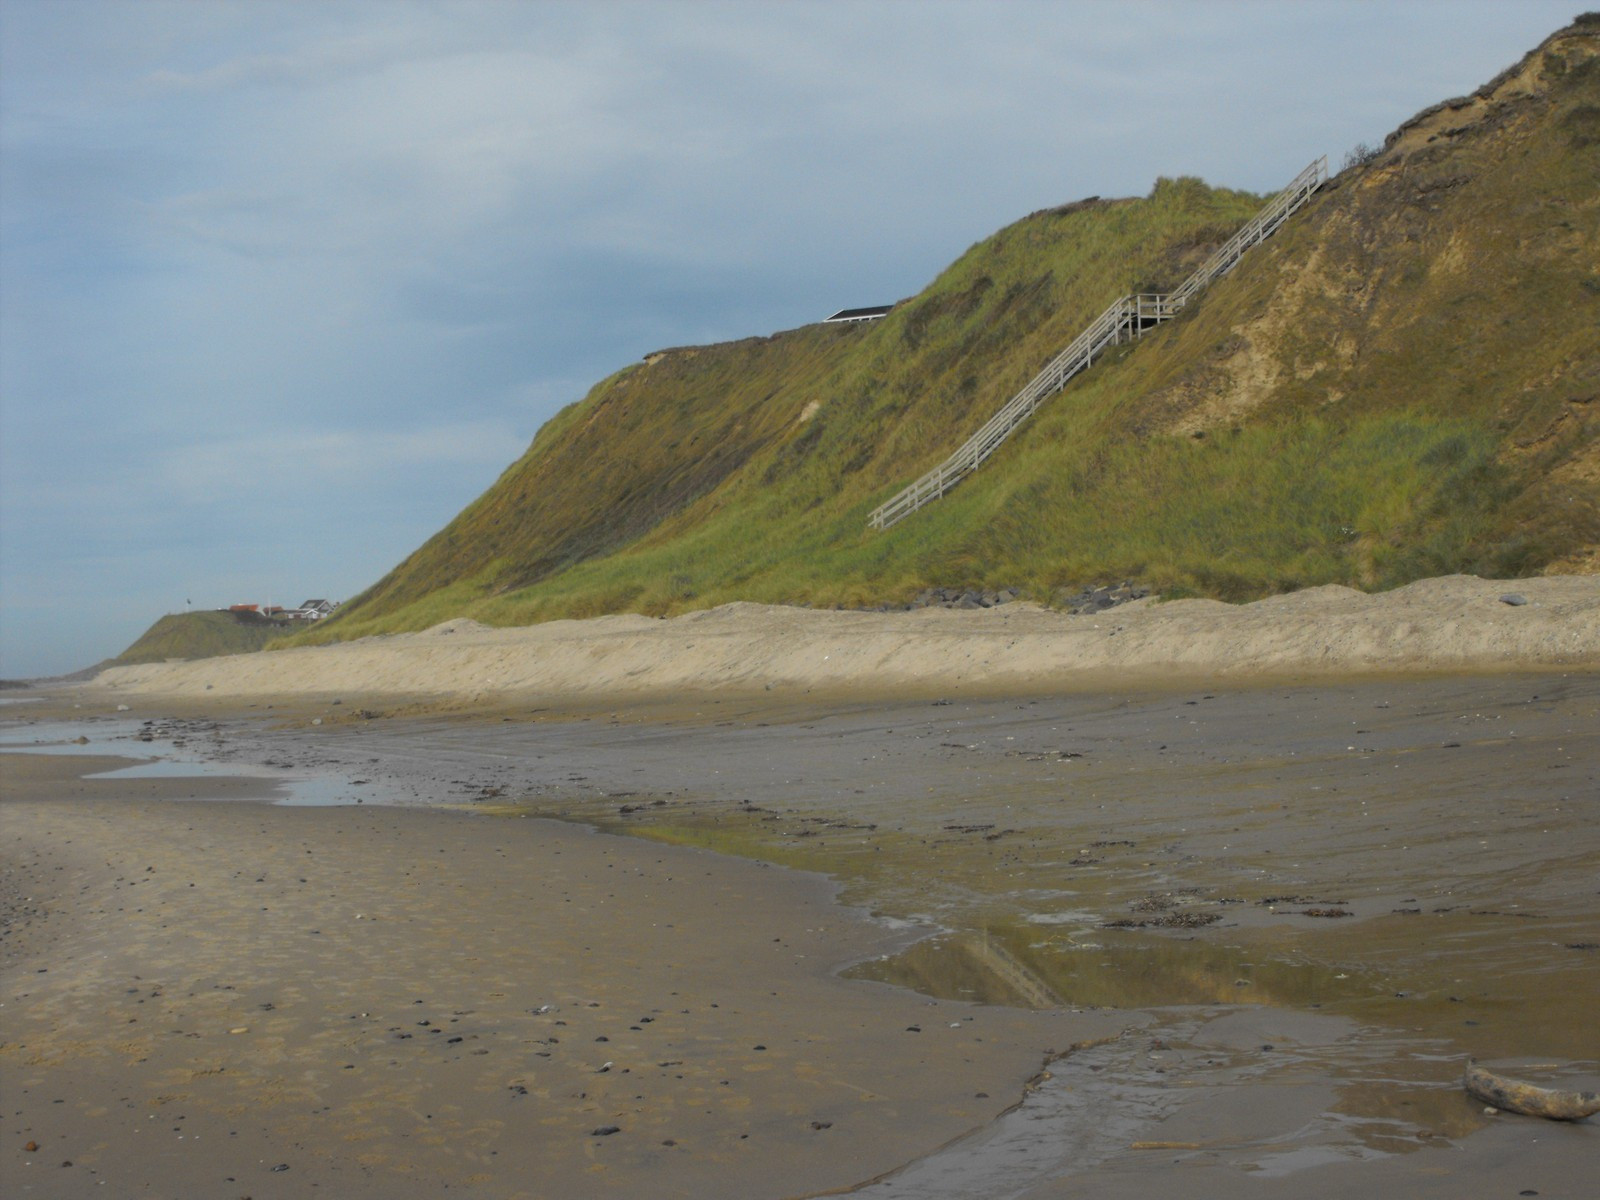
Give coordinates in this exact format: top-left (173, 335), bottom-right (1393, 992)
top-left (851, 1010), bottom-right (1488, 1200)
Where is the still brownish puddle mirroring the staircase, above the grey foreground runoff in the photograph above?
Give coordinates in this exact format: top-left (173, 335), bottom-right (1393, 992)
top-left (515, 797), bottom-right (1600, 1059)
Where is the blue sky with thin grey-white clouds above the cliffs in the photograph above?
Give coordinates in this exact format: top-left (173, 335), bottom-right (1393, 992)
top-left (0, 0), bottom-right (1584, 678)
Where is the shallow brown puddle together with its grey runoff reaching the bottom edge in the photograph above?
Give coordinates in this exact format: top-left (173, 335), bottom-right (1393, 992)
top-left (556, 798), bottom-right (1597, 1177)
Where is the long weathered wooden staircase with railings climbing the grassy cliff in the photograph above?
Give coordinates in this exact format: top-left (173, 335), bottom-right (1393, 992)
top-left (867, 157), bottom-right (1328, 530)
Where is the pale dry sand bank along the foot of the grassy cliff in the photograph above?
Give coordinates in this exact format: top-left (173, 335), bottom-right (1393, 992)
top-left (98, 576), bottom-right (1600, 702)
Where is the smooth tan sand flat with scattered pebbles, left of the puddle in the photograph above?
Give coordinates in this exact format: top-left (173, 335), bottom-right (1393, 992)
top-left (0, 755), bottom-right (1126, 1200)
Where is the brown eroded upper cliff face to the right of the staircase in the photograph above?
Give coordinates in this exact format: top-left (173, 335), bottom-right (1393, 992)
top-left (1149, 24), bottom-right (1600, 451)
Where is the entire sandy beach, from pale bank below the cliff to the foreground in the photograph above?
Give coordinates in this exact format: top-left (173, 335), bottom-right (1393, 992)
top-left (0, 579), bottom-right (1600, 1200)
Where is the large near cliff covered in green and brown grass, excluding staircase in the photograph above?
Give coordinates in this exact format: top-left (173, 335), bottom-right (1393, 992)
top-left (310, 19), bottom-right (1600, 640)
